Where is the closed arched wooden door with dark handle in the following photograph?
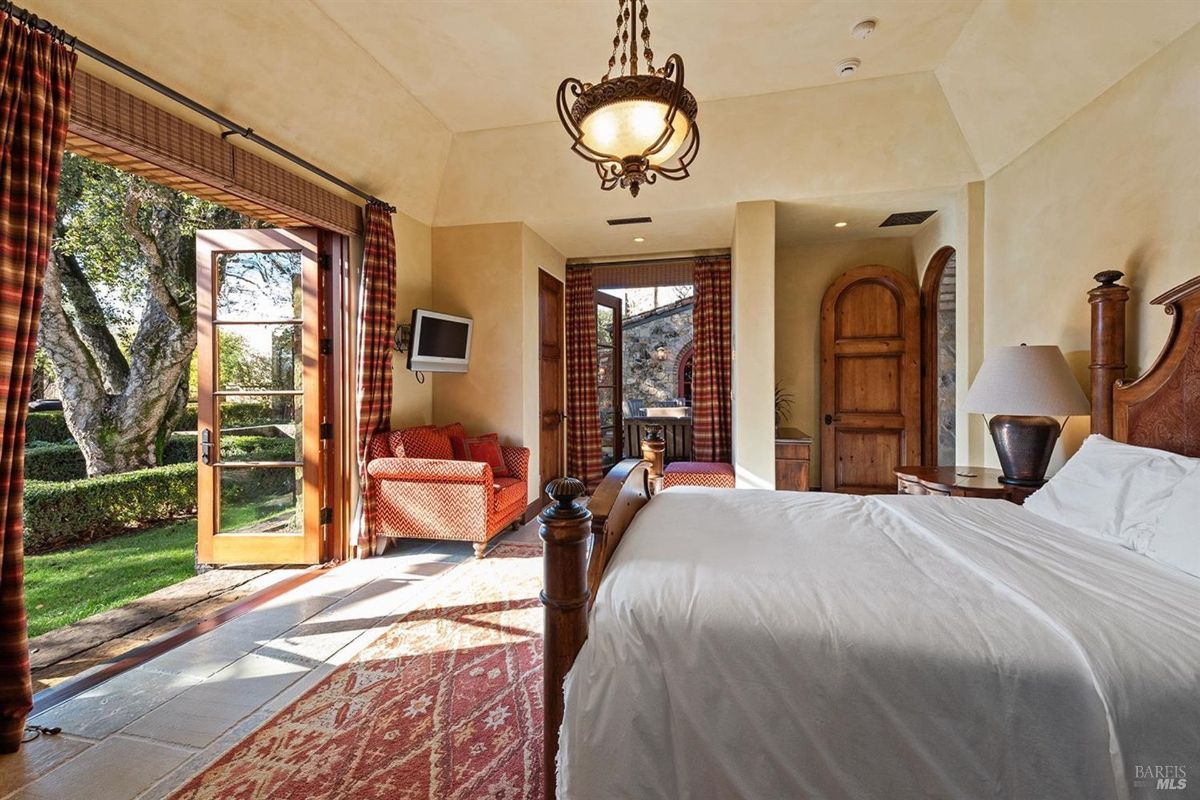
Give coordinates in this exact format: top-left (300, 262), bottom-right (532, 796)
top-left (821, 265), bottom-right (922, 494)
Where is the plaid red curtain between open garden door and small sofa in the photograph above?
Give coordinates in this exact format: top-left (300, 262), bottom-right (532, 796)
top-left (355, 203), bottom-right (396, 555)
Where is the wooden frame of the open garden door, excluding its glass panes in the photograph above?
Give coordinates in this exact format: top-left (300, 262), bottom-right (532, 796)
top-left (196, 228), bottom-right (338, 564)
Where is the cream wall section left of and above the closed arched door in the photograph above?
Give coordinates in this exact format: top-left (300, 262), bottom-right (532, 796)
top-left (775, 231), bottom-right (916, 486)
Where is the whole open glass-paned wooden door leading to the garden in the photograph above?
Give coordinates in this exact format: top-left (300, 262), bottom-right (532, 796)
top-left (196, 228), bottom-right (331, 564)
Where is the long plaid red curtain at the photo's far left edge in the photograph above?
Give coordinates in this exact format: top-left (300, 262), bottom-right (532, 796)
top-left (0, 12), bottom-right (76, 752)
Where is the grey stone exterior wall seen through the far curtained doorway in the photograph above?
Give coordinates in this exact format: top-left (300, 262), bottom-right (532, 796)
top-left (622, 297), bottom-right (692, 408)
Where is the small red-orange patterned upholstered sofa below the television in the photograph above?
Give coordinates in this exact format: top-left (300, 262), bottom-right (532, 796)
top-left (367, 422), bottom-right (529, 558)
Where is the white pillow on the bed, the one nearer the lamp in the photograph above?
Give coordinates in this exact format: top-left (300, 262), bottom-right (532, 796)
top-left (1025, 434), bottom-right (1200, 553)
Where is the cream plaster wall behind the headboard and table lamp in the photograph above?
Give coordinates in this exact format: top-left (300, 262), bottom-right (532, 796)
top-left (984, 28), bottom-right (1200, 470)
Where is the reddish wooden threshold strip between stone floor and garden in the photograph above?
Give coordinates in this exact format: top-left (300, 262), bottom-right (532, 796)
top-left (29, 564), bottom-right (337, 717)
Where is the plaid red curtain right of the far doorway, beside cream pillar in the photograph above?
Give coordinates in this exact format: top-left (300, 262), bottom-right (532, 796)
top-left (691, 258), bottom-right (733, 463)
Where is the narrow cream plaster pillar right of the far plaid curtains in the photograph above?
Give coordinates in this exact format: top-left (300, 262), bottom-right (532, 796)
top-left (732, 200), bottom-right (775, 489)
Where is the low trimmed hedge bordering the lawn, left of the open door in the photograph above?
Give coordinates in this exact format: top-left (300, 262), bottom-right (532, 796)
top-left (25, 464), bottom-right (196, 553)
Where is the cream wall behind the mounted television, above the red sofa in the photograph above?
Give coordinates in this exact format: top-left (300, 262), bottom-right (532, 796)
top-left (430, 222), bottom-right (566, 500)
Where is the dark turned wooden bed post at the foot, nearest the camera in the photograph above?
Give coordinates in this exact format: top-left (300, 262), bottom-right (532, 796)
top-left (538, 477), bottom-right (592, 800)
